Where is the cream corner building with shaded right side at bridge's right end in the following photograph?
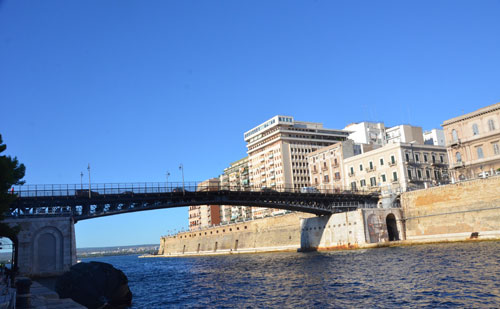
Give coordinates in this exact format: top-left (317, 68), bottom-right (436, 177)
top-left (344, 143), bottom-right (448, 195)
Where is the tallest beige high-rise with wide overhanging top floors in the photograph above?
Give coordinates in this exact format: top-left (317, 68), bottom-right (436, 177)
top-left (244, 115), bottom-right (349, 218)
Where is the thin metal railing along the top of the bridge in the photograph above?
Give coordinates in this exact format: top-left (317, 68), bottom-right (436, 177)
top-left (10, 182), bottom-right (380, 197)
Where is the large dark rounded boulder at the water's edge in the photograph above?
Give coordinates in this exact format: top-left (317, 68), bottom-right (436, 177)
top-left (56, 262), bottom-right (132, 308)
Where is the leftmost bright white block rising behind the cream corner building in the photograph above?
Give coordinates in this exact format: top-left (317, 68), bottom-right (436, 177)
top-left (344, 121), bottom-right (387, 148)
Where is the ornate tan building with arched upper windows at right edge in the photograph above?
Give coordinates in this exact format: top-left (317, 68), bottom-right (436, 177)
top-left (442, 103), bottom-right (500, 181)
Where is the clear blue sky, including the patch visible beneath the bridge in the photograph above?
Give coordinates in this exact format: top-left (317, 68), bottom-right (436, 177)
top-left (0, 0), bottom-right (500, 247)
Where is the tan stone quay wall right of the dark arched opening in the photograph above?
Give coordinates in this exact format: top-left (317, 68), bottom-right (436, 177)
top-left (401, 176), bottom-right (500, 242)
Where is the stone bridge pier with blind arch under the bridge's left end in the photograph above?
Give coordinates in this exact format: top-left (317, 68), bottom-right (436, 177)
top-left (4, 217), bottom-right (76, 277)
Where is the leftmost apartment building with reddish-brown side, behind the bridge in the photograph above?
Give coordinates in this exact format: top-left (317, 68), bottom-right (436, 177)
top-left (188, 178), bottom-right (221, 231)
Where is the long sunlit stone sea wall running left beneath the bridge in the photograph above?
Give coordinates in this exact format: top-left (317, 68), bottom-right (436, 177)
top-left (158, 213), bottom-right (314, 256)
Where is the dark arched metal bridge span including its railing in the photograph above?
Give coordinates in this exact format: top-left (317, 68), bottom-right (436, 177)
top-left (10, 185), bottom-right (378, 221)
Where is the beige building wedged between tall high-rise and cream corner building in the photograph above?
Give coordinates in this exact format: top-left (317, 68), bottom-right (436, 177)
top-left (307, 140), bottom-right (356, 192)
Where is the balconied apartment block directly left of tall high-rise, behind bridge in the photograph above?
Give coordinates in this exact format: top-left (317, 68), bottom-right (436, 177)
top-left (219, 157), bottom-right (252, 223)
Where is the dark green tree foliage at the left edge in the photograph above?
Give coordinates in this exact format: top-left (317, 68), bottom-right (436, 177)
top-left (0, 134), bottom-right (26, 236)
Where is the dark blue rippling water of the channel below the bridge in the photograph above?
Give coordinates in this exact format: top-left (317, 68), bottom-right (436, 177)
top-left (84, 242), bottom-right (500, 308)
